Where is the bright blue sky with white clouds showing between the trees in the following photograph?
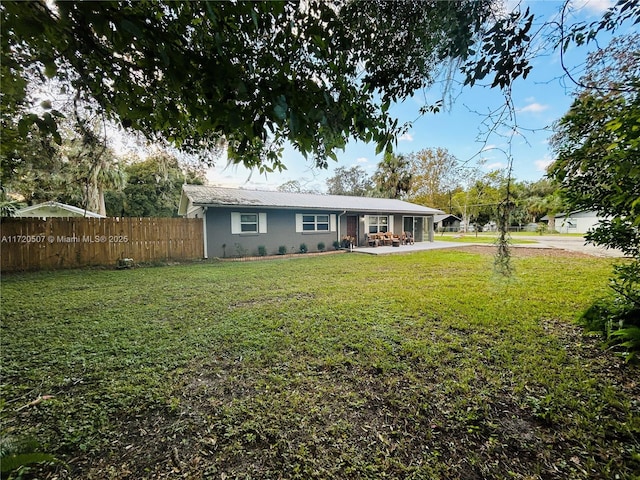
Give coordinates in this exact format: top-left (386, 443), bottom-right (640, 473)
top-left (208, 0), bottom-right (628, 191)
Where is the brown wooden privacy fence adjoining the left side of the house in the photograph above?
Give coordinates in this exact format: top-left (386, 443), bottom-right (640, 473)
top-left (0, 217), bottom-right (204, 271)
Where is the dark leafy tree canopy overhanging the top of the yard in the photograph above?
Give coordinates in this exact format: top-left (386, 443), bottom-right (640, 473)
top-left (0, 0), bottom-right (532, 170)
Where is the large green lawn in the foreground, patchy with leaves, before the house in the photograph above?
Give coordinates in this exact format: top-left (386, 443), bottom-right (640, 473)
top-left (0, 247), bottom-right (640, 479)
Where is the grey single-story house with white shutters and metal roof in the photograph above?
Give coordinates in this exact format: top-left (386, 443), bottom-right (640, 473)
top-left (178, 185), bottom-right (443, 257)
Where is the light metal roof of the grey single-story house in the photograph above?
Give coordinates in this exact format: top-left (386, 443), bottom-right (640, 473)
top-left (180, 185), bottom-right (443, 215)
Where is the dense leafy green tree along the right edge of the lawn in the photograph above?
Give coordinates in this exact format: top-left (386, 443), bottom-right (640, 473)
top-left (549, 34), bottom-right (640, 351)
